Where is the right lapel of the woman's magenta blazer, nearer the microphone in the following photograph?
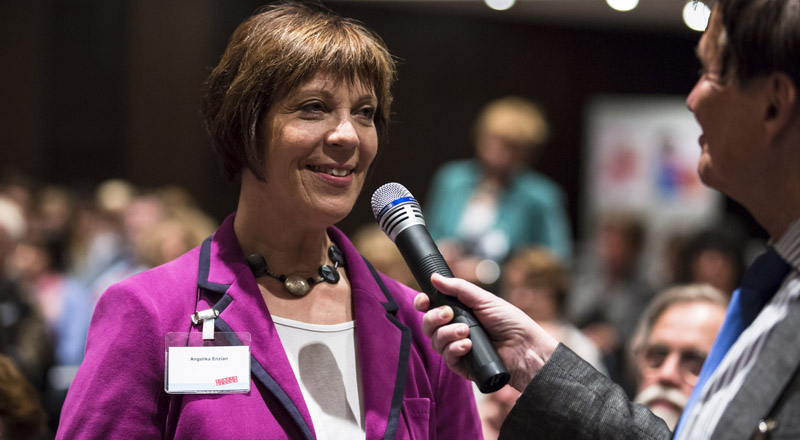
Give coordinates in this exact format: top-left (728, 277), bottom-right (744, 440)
top-left (328, 228), bottom-right (411, 439)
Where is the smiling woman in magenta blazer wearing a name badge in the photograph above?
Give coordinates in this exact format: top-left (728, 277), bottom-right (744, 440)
top-left (58, 3), bottom-right (480, 439)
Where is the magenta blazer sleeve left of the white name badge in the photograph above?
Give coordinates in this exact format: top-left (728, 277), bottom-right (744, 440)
top-left (57, 285), bottom-right (164, 440)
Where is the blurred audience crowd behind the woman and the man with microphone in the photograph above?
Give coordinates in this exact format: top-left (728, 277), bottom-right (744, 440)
top-left (0, 164), bottom-right (756, 440)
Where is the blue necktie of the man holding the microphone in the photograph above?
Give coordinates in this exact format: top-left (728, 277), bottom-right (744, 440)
top-left (675, 247), bottom-right (791, 438)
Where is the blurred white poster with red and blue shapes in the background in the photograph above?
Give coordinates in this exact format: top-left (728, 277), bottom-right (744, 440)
top-left (582, 95), bottom-right (723, 282)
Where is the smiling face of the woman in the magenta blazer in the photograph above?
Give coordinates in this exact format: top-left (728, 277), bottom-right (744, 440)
top-left (261, 73), bottom-right (378, 224)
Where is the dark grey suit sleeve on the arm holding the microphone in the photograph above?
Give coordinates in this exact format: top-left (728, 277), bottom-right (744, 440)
top-left (500, 344), bottom-right (672, 440)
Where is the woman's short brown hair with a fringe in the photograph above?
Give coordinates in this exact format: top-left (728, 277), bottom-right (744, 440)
top-left (202, 2), bottom-right (395, 181)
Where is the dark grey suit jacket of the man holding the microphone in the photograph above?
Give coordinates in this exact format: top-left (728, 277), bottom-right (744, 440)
top-left (500, 301), bottom-right (800, 440)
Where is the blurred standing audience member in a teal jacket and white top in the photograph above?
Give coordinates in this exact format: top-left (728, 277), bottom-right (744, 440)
top-left (425, 96), bottom-right (572, 286)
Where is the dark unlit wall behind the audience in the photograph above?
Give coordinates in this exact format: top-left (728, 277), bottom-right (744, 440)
top-left (0, 0), bottom-right (756, 242)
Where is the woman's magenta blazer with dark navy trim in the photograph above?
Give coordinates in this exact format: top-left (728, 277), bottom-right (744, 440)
top-left (57, 215), bottom-right (482, 440)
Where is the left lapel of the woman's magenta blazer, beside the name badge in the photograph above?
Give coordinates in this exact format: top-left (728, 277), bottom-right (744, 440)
top-left (198, 215), bottom-right (314, 439)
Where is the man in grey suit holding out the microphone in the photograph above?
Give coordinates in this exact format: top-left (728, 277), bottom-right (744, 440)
top-left (415, 0), bottom-right (800, 439)
